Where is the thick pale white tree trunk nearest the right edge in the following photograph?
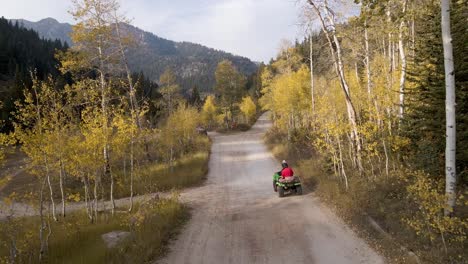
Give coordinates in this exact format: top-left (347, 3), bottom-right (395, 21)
top-left (441, 0), bottom-right (457, 215)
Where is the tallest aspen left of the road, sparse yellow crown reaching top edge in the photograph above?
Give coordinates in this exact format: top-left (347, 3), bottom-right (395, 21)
top-left (69, 0), bottom-right (119, 213)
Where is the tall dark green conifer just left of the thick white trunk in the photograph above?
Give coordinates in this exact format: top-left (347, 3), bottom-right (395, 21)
top-left (403, 1), bottom-right (445, 175)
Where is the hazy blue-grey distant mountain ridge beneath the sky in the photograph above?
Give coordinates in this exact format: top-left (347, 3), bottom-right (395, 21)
top-left (10, 17), bottom-right (258, 92)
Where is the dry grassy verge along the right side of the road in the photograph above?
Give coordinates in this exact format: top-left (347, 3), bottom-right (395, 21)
top-left (265, 132), bottom-right (468, 263)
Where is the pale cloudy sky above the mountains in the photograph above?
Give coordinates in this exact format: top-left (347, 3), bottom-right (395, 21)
top-left (0, 0), bottom-right (303, 62)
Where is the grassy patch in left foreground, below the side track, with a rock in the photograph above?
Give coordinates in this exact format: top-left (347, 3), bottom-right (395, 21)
top-left (0, 196), bottom-right (189, 263)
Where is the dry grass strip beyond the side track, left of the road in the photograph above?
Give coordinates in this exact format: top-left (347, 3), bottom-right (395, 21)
top-left (0, 142), bottom-right (211, 200)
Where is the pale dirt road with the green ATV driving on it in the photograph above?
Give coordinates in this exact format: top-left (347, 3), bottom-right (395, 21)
top-left (160, 115), bottom-right (384, 264)
